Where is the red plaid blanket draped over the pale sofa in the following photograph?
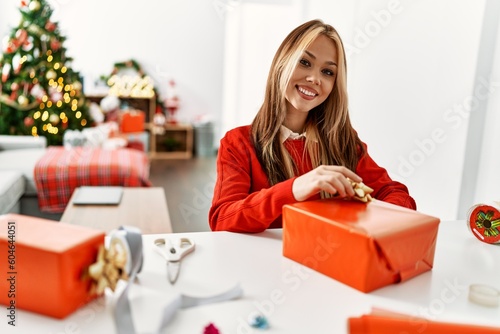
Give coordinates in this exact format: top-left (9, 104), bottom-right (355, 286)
top-left (34, 146), bottom-right (151, 213)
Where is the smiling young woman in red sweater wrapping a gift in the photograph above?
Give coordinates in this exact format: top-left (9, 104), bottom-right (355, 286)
top-left (209, 20), bottom-right (416, 233)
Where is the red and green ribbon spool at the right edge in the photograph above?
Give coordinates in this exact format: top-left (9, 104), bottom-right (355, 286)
top-left (466, 202), bottom-right (500, 244)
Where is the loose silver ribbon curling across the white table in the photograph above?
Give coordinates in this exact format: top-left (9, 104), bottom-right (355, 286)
top-left (113, 226), bottom-right (243, 334)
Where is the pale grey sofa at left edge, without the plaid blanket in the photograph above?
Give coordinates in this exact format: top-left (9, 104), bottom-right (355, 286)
top-left (0, 135), bottom-right (59, 219)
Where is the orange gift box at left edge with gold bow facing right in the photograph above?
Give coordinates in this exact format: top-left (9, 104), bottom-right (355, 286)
top-left (0, 214), bottom-right (105, 318)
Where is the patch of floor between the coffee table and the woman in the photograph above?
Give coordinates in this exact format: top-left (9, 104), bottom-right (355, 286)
top-left (150, 155), bottom-right (217, 233)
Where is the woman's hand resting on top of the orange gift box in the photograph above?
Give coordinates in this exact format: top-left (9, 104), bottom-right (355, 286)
top-left (292, 165), bottom-right (362, 202)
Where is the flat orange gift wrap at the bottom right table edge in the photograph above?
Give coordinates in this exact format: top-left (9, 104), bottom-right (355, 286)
top-left (348, 311), bottom-right (500, 334)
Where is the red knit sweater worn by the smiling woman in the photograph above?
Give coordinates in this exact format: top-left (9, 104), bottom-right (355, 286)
top-left (209, 125), bottom-right (416, 233)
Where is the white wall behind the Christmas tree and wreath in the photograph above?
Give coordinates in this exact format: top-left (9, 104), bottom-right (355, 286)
top-left (0, 0), bottom-right (224, 125)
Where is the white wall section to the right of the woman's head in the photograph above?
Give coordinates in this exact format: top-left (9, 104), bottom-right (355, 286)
top-left (342, 0), bottom-right (484, 220)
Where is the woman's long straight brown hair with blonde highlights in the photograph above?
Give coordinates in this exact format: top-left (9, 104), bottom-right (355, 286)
top-left (251, 20), bottom-right (364, 197)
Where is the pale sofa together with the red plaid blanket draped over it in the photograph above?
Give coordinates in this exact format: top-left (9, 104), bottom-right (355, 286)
top-left (0, 132), bottom-right (151, 220)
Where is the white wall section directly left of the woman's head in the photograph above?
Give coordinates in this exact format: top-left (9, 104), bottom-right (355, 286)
top-left (219, 0), bottom-right (302, 137)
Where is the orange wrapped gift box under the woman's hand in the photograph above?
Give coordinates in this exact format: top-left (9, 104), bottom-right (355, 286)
top-left (283, 199), bottom-right (440, 292)
